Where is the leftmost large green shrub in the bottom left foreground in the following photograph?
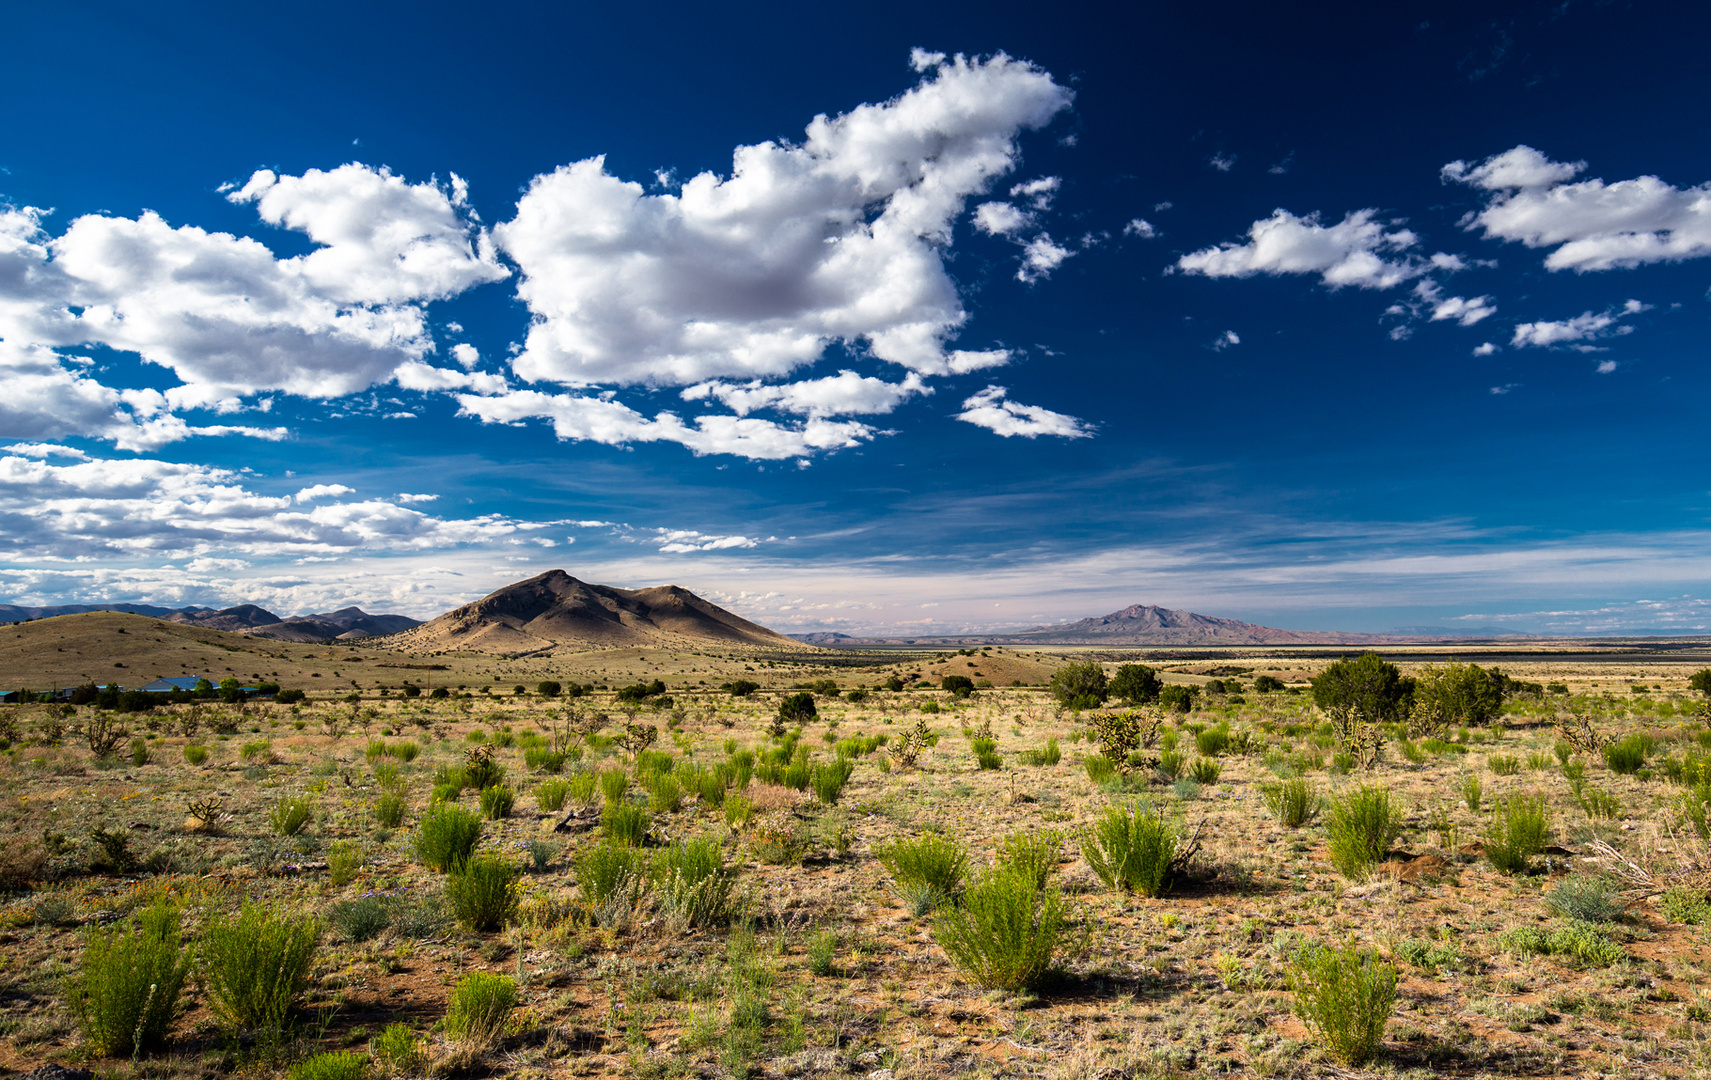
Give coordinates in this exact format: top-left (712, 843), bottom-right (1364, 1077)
top-left (65, 899), bottom-right (190, 1058)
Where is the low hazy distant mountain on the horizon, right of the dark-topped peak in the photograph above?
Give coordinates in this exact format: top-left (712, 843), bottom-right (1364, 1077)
top-left (790, 604), bottom-right (1528, 649)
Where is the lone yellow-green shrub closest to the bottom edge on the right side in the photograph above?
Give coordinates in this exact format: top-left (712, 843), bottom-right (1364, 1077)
top-left (1288, 945), bottom-right (1396, 1065)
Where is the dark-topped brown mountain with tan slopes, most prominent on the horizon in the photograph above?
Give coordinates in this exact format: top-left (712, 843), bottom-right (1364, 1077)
top-left (390, 570), bottom-right (796, 654)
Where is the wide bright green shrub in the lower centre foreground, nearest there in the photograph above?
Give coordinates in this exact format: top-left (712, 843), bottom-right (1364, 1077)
top-left (932, 869), bottom-right (1063, 991)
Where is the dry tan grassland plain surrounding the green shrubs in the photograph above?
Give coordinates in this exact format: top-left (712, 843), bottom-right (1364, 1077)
top-left (0, 646), bottom-right (1711, 1080)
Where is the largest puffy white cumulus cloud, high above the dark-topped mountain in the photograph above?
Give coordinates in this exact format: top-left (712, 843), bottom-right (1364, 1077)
top-left (494, 53), bottom-right (1071, 387)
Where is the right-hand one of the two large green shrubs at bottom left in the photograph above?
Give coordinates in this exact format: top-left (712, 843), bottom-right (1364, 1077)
top-left (202, 902), bottom-right (320, 1030)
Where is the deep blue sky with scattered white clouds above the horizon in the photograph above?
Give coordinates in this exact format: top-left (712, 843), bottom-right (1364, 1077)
top-left (0, 2), bottom-right (1711, 633)
